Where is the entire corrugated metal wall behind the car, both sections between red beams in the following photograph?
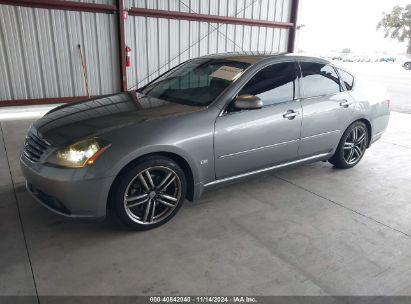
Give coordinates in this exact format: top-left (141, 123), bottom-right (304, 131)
top-left (0, 0), bottom-right (292, 102)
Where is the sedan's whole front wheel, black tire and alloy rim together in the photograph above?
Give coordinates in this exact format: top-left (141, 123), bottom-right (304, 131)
top-left (111, 156), bottom-right (186, 230)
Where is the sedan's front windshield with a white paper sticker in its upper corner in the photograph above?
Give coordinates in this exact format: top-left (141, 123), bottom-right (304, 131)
top-left (140, 58), bottom-right (250, 106)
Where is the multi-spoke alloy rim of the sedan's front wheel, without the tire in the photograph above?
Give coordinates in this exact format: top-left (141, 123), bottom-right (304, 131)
top-left (124, 166), bottom-right (181, 225)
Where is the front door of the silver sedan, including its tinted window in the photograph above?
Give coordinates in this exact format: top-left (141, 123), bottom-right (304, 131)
top-left (214, 62), bottom-right (301, 179)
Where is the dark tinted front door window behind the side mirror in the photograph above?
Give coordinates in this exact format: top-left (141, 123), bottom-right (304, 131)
top-left (239, 62), bottom-right (297, 106)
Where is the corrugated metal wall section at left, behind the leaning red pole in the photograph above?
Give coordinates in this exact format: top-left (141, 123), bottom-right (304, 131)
top-left (0, 1), bottom-right (120, 102)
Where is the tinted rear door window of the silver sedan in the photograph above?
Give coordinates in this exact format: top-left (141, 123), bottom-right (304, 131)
top-left (300, 62), bottom-right (341, 97)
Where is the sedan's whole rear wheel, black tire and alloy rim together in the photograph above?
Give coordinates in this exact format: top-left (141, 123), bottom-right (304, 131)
top-left (329, 121), bottom-right (369, 169)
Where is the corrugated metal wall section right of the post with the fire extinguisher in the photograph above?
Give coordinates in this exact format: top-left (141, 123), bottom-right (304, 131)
top-left (125, 0), bottom-right (291, 89)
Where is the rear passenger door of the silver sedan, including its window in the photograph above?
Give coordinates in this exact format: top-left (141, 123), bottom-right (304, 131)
top-left (298, 62), bottom-right (353, 158)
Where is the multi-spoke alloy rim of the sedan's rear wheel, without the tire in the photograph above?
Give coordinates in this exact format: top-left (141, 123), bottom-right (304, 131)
top-left (344, 126), bottom-right (367, 165)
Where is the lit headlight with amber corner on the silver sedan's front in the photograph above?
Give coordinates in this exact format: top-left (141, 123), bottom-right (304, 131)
top-left (47, 138), bottom-right (111, 168)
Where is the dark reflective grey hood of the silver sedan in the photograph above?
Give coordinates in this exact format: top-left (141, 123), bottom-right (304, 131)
top-left (33, 92), bottom-right (204, 147)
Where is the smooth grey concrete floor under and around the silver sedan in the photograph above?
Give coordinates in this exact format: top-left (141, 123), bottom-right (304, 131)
top-left (0, 113), bottom-right (411, 296)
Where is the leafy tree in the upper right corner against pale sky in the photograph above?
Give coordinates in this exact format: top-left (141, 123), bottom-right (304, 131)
top-left (377, 4), bottom-right (411, 54)
